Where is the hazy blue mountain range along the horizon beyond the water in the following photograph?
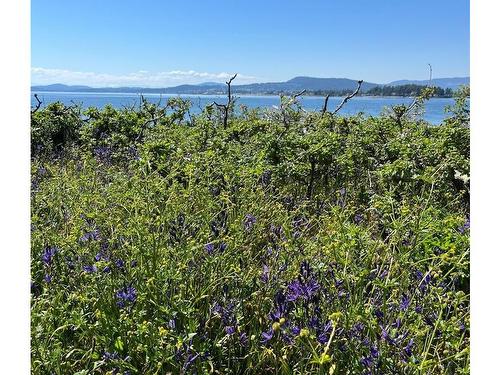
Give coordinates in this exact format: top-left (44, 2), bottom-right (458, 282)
top-left (31, 77), bottom-right (470, 95)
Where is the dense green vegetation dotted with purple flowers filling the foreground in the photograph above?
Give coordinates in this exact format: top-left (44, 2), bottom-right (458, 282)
top-left (31, 92), bottom-right (469, 374)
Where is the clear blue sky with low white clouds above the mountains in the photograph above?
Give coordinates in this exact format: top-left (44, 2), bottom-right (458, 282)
top-left (31, 0), bottom-right (470, 87)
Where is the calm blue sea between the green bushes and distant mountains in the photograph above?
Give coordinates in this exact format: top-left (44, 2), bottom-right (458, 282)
top-left (31, 92), bottom-right (460, 124)
